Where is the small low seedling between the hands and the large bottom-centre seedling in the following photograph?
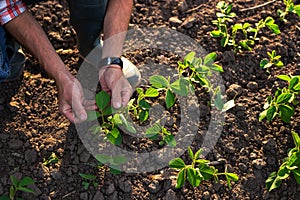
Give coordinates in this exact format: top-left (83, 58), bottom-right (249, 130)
top-left (146, 122), bottom-right (176, 147)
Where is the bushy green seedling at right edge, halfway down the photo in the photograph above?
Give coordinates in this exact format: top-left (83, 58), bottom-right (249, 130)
top-left (259, 75), bottom-right (300, 123)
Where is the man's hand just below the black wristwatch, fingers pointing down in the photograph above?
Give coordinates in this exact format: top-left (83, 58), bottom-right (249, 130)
top-left (99, 65), bottom-right (133, 109)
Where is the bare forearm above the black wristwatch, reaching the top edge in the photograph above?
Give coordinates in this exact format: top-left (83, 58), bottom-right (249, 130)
top-left (102, 0), bottom-right (133, 57)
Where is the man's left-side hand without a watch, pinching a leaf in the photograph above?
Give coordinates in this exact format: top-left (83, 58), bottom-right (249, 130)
top-left (57, 73), bottom-right (96, 123)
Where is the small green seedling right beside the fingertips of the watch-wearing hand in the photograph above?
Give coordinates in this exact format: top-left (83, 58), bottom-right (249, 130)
top-left (127, 87), bottom-right (159, 122)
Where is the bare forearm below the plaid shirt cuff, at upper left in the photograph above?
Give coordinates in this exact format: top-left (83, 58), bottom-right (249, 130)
top-left (4, 11), bottom-right (68, 81)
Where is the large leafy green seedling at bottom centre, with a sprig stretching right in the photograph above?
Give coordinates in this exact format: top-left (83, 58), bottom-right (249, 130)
top-left (169, 147), bottom-right (238, 189)
